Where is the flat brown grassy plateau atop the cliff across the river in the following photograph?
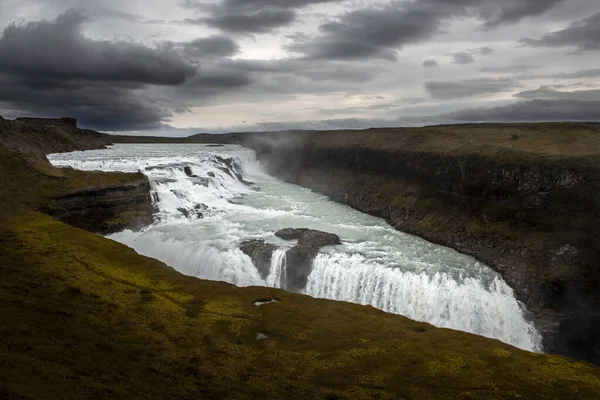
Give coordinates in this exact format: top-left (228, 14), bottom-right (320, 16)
top-left (313, 123), bottom-right (600, 161)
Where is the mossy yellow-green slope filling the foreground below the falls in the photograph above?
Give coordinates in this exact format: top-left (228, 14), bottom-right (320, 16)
top-left (0, 124), bottom-right (600, 399)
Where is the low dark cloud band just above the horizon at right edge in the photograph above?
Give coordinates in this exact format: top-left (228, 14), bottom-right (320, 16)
top-left (438, 100), bottom-right (600, 122)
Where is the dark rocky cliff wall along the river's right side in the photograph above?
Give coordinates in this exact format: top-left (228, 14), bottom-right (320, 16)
top-left (248, 126), bottom-right (600, 363)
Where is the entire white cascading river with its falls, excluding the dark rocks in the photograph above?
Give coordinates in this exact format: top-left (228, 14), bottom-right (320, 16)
top-left (49, 145), bottom-right (541, 351)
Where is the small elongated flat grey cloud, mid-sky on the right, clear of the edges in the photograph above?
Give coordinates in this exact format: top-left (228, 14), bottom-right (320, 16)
top-left (425, 78), bottom-right (519, 100)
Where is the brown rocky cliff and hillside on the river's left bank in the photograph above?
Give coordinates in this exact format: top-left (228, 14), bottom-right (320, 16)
top-left (0, 118), bottom-right (154, 234)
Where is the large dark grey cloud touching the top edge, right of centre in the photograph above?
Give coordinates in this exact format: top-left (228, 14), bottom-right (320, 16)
top-left (287, 0), bottom-right (565, 60)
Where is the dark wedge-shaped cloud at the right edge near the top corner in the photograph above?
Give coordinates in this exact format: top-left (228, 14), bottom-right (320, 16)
top-left (521, 13), bottom-right (600, 51)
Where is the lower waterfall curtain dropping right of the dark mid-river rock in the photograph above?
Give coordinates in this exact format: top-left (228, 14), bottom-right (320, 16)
top-left (304, 253), bottom-right (541, 350)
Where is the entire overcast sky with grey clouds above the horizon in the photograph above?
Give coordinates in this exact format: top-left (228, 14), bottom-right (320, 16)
top-left (0, 0), bottom-right (600, 136)
